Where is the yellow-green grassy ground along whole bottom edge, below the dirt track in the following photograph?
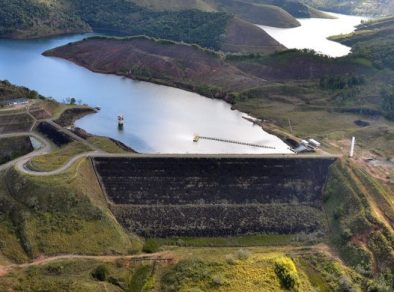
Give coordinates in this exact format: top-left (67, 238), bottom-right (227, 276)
top-left (0, 248), bottom-right (370, 291)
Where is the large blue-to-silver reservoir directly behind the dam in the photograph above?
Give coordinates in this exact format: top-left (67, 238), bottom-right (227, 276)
top-left (0, 35), bottom-right (290, 153)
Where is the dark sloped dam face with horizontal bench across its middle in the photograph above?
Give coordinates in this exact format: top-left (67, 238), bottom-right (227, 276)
top-left (93, 155), bottom-right (335, 237)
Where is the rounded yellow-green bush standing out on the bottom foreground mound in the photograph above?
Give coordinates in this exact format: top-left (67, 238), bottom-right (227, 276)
top-left (275, 257), bottom-right (299, 289)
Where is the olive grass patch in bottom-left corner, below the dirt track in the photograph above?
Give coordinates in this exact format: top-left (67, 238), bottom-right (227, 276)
top-left (0, 258), bottom-right (152, 292)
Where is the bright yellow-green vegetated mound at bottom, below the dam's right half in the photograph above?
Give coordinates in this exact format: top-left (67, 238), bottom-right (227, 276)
top-left (161, 249), bottom-right (366, 291)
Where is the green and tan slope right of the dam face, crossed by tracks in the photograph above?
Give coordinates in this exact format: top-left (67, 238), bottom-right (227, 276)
top-left (324, 162), bottom-right (394, 290)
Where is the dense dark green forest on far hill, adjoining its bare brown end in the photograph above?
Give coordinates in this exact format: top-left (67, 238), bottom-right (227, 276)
top-left (73, 0), bottom-right (230, 49)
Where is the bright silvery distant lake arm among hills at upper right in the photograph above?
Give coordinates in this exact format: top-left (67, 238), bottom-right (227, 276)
top-left (259, 13), bottom-right (367, 57)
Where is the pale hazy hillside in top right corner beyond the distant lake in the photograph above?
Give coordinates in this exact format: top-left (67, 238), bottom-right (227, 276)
top-left (304, 0), bottom-right (394, 16)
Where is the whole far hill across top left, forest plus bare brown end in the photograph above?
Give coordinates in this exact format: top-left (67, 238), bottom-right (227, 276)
top-left (0, 0), bottom-right (283, 52)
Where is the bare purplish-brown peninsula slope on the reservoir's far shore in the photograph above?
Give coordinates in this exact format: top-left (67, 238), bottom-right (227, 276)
top-left (45, 38), bottom-right (264, 97)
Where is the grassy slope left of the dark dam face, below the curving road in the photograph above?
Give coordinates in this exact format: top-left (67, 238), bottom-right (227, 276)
top-left (0, 160), bottom-right (138, 262)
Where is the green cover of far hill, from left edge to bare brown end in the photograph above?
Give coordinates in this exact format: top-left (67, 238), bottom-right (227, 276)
top-left (0, 0), bottom-right (231, 49)
